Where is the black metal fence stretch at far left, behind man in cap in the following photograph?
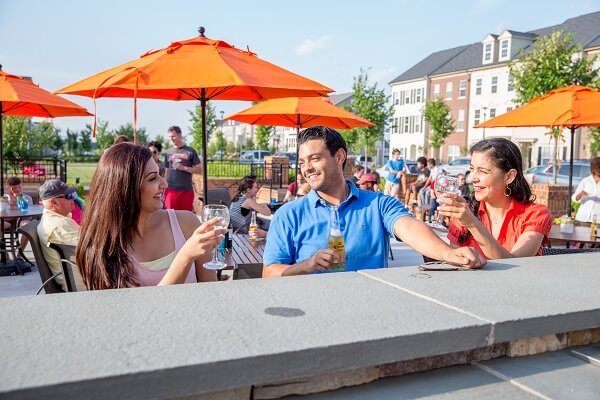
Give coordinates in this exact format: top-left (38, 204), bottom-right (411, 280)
top-left (2, 158), bottom-right (67, 185)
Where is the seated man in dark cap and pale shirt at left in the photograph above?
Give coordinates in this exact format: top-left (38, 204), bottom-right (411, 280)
top-left (37, 179), bottom-right (85, 292)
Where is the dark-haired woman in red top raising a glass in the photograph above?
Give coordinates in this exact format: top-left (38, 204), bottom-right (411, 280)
top-left (438, 138), bottom-right (552, 259)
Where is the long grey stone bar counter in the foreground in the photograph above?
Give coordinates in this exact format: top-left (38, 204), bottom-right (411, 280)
top-left (0, 253), bottom-right (600, 399)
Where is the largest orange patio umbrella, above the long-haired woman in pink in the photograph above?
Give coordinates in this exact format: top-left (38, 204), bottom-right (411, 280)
top-left (57, 27), bottom-right (333, 203)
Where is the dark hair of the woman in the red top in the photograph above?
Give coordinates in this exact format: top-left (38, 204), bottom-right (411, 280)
top-left (458, 138), bottom-right (535, 244)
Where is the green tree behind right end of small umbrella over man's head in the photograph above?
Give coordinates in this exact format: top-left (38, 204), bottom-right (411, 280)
top-left (342, 69), bottom-right (392, 162)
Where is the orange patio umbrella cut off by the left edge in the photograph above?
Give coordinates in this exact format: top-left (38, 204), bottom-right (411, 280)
top-left (0, 65), bottom-right (92, 195)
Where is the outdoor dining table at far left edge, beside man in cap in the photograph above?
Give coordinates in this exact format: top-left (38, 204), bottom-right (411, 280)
top-left (0, 205), bottom-right (44, 276)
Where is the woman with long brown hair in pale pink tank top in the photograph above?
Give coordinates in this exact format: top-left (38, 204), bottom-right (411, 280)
top-left (77, 143), bottom-right (226, 290)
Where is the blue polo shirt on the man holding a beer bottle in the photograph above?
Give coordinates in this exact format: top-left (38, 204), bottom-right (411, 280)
top-left (263, 181), bottom-right (410, 271)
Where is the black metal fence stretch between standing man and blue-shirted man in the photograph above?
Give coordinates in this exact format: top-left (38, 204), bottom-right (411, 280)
top-left (208, 161), bottom-right (294, 188)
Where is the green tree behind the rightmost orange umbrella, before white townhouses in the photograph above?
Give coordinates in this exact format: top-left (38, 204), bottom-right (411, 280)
top-left (509, 31), bottom-right (600, 183)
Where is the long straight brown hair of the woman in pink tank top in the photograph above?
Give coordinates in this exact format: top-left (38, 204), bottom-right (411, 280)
top-left (76, 143), bottom-right (152, 290)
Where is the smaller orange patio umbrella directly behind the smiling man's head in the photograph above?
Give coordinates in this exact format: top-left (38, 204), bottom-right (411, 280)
top-left (225, 97), bottom-right (375, 176)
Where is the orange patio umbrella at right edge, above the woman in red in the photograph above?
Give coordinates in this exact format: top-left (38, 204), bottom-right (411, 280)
top-left (476, 85), bottom-right (600, 216)
